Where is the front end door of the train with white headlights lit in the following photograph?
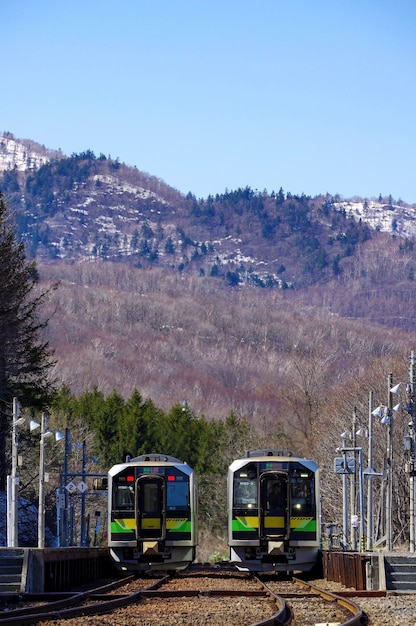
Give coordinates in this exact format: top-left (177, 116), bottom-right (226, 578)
top-left (260, 472), bottom-right (288, 539)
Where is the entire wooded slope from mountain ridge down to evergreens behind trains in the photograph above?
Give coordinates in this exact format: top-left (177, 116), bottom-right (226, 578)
top-left (0, 138), bottom-right (416, 543)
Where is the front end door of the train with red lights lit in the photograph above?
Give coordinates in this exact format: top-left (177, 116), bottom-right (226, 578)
top-left (136, 474), bottom-right (166, 540)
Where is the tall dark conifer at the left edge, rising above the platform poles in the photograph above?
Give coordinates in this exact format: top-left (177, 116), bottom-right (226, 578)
top-left (0, 192), bottom-right (53, 489)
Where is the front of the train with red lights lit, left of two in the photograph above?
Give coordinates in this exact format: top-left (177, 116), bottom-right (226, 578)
top-left (108, 455), bottom-right (197, 571)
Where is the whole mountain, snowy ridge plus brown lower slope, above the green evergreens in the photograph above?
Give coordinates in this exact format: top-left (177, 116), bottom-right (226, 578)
top-left (0, 133), bottom-right (416, 432)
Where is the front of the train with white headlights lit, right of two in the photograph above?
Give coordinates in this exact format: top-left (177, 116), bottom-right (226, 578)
top-left (228, 456), bottom-right (320, 572)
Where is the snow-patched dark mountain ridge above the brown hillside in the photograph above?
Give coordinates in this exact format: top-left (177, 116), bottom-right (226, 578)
top-left (0, 133), bottom-right (416, 289)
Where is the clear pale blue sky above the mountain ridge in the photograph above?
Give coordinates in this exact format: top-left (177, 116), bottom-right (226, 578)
top-left (0, 0), bottom-right (416, 203)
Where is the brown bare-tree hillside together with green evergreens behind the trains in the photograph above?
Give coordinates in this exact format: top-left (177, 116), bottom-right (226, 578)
top-left (6, 256), bottom-right (412, 551)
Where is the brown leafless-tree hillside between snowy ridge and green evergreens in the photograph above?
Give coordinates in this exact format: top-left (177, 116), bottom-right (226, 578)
top-left (41, 256), bottom-right (414, 432)
